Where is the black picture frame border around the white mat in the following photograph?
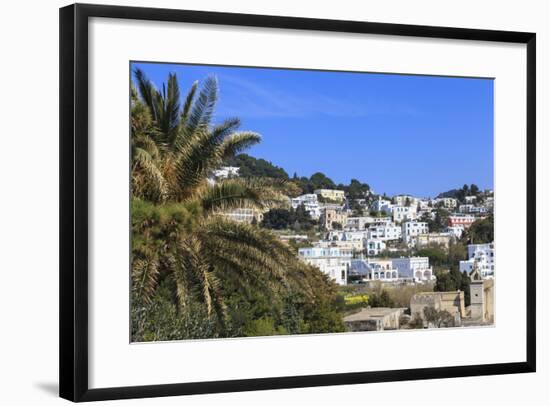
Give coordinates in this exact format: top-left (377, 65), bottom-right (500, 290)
top-left (59, 4), bottom-right (536, 402)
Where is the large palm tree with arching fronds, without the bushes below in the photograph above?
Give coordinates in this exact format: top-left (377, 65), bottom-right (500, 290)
top-left (131, 69), bottom-right (342, 340)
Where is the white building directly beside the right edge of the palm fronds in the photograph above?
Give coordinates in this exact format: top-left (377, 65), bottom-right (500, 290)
top-left (298, 247), bottom-right (352, 285)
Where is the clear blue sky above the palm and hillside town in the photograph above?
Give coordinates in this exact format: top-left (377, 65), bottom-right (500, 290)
top-left (132, 63), bottom-right (493, 196)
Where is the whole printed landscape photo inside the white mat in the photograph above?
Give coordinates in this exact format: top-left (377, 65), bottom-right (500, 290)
top-left (129, 62), bottom-right (496, 342)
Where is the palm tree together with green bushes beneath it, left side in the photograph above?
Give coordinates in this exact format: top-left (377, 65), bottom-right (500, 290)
top-left (131, 70), bottom-right (344, 341)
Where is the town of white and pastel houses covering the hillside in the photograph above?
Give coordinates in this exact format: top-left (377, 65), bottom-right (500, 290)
top-left (211, 166), bottom-right (495, 331)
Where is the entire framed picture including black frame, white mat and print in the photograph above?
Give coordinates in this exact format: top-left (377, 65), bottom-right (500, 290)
top-left (60, 4), bottom-right (536, 401)
